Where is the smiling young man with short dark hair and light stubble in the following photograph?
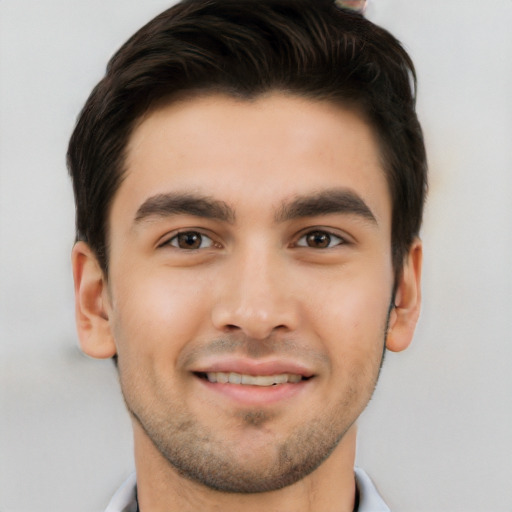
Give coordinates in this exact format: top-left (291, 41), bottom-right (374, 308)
top-left (68, 0), bottom-right (426, 512)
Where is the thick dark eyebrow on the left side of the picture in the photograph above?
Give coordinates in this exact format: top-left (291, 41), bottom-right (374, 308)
top-left (134, 192), bottom-right (235, 224)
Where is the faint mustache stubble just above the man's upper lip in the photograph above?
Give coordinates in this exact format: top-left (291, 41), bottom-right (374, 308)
top-left (178, 334), bottom-right (330, 368)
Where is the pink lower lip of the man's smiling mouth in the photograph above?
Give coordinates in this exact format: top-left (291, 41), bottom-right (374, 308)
top-left (197, 377), bottom-right (313, 406)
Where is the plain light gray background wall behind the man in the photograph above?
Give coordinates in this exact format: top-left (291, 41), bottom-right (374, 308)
top-left (0, 0), bottom-right (512, 512)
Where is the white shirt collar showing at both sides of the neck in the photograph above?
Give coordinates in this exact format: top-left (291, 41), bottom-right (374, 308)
top-left (105, 468), bottom-right (391, 512)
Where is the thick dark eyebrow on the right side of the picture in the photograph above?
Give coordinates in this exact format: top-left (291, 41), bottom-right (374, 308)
top-left (275, 188), bottom-right (377, 224)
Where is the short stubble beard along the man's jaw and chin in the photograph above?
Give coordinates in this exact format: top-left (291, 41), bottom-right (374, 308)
top-left (121, 308), bottom-right (391, 494)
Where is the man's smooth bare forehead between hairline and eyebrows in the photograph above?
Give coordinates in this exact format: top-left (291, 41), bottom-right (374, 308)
top-left (113, 93), bottom-right (391, 228)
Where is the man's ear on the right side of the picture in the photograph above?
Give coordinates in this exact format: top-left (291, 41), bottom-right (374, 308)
top-left (386, 239), bottom-right (423, 352)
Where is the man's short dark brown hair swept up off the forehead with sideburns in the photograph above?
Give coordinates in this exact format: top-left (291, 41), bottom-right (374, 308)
top-left (68, 0), bottom-right (427, 274)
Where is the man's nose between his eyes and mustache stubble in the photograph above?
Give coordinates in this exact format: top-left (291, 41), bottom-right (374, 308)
top-left (212, 244), bottom-right (300, 340)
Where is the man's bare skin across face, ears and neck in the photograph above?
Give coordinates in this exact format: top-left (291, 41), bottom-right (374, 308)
top-left (73, 92), bottom-right (421, 512)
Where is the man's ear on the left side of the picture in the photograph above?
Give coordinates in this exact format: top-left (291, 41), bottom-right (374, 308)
top-left (71, 242), bottom-right (116, 358)
